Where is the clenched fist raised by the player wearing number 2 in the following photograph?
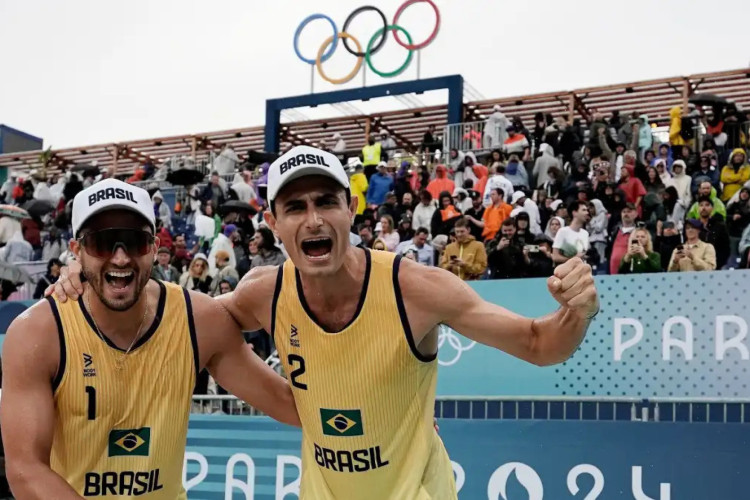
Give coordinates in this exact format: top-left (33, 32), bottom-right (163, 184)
top-left (547, 257), bottom-right (599, 319)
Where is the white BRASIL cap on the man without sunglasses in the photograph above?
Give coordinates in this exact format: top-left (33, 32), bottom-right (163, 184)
top-left (268, 146), bottom-right (349, 203)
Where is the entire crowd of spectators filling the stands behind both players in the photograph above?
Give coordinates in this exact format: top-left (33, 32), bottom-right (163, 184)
top-left (0, 105), bottom-right (750, 308)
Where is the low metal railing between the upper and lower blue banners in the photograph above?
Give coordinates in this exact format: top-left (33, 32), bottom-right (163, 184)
top-left (188, 395), bottom-right (750, 423)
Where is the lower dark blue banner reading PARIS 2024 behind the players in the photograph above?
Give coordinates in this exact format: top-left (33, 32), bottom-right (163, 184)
top-left (183, 415), bottom-right (750, 500)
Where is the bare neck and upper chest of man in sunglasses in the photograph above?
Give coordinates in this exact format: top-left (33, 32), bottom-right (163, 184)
top-left (84, 280), bottom-right (161, 349)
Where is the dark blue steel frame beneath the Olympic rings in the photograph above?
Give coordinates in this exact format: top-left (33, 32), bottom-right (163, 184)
top-left (264, 75), bottom-right (464, 153)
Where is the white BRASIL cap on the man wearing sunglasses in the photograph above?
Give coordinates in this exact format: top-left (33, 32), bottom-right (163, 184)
top-left (72, 179), bottom-right (156, 238)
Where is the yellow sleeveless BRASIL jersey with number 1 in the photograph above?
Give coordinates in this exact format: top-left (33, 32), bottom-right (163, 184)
top-left (49, 281), bottom-right (198, 500)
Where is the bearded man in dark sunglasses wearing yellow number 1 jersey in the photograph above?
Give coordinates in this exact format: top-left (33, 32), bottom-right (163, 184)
top-left (0, 179), bottom-right (299, 500)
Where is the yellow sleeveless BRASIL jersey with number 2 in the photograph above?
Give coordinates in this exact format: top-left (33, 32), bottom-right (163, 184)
top-left (271, 250), bottom-right (456, 500)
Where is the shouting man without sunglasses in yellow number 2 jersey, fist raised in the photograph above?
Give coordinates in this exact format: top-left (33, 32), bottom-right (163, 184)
top-left (57, 146), bottom-right (599, 500)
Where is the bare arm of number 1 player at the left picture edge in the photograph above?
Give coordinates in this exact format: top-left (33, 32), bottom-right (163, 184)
top-left (0, 301), bottom-right (82, 500)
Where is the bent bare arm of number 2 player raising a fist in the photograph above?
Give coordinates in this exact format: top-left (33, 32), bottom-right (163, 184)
top-left (399, 260), bottom-right (598, 366)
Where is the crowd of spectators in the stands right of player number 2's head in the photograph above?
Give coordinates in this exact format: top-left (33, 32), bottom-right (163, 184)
top-left (340, 105), bottom-right (750, 280)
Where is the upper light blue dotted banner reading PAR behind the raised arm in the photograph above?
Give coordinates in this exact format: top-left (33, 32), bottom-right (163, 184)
top-left (5, 271), bottom-right (750, 398)
